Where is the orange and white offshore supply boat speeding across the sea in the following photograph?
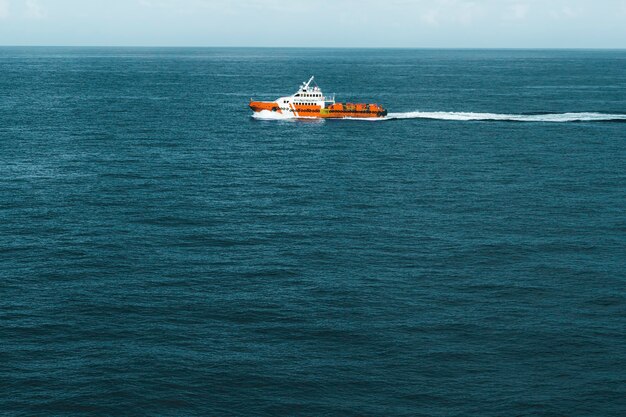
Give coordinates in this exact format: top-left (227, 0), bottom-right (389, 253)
top-left (250, 77), bottom-right (387, 119)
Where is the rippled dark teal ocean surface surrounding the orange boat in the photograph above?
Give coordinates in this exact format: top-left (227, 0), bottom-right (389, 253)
top-left (0, 48), bottom-right (626, 417)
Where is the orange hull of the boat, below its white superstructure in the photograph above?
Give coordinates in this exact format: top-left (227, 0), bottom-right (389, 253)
top-left (250, 101), bottom-right (387, 119)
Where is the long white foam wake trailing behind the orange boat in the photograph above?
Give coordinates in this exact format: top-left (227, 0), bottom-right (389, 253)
top-left (386, 111), bottom-right (626, 123)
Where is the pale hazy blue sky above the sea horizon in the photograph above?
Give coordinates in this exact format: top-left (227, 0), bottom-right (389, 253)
top-left (0, 0), bottom-right (626, 48)
